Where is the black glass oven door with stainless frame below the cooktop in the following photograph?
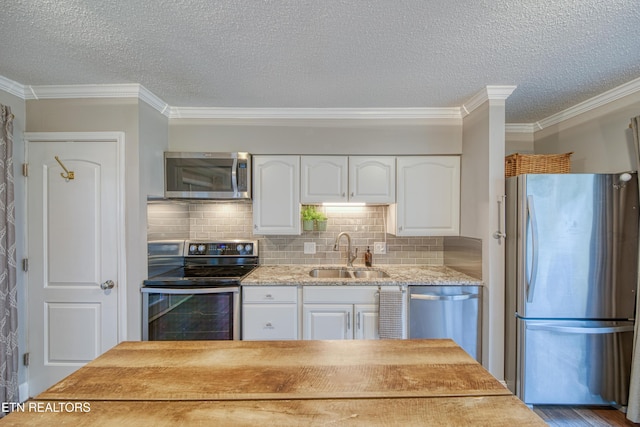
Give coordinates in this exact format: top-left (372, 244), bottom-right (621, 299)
top-left (142, 286), bottom-right (240, 341)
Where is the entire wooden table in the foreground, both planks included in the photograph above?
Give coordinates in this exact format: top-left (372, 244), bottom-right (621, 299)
top-left (2, 340), bottom-right (546, 426)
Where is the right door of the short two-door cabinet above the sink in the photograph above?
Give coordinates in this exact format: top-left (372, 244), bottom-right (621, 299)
top-left (349, 156), bottom-right (396, 203)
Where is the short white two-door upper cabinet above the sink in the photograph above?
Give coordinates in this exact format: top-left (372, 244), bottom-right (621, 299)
top-left (301, 156), bottom-right (396, 204)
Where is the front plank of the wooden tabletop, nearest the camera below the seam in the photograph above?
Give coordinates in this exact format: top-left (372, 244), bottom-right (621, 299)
top-left (0, 395), bottom-right (547, 427)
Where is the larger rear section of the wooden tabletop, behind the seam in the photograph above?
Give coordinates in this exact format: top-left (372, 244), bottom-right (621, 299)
top-left (37, 340), bottom-right (511, 401)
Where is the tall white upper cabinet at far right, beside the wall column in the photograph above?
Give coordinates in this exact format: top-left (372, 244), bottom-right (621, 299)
top-left (387, 156), bottom-right (460, 236)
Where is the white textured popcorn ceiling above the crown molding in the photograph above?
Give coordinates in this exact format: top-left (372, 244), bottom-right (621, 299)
top-left (0, 0), bottom-right (640, 123)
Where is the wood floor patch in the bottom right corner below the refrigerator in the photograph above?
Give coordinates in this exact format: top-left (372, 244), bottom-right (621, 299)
top-left (533, 405), bottom-right (640, 427)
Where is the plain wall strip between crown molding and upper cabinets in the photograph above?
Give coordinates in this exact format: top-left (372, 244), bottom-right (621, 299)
top-left (169, 119), bottom-right (462, 155)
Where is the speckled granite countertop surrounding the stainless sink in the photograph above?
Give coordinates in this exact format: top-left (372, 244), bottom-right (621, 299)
top-left (242, 264), bottom-right (482, 286)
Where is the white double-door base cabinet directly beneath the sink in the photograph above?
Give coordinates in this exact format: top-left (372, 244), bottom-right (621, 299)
top-left (302, 286), bottom-right (379, 340)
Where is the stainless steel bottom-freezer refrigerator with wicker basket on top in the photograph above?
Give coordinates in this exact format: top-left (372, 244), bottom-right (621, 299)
top-left (505, 173), bottom-right (639, 405)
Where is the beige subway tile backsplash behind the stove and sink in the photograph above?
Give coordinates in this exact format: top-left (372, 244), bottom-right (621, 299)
top-left (147, 201), bottom-right (444, 266)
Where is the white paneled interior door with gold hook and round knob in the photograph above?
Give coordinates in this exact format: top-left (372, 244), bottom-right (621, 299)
top-left (25, 134), bottom-right (124, 396)
